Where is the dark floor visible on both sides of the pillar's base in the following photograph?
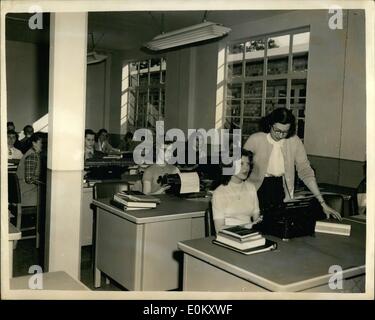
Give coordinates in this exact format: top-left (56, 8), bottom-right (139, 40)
top-left (13, 239), bottom-right (126, 291)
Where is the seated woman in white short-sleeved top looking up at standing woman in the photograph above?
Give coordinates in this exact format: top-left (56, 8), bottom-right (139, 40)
top-left (212, 150), bottom-right (260, 232)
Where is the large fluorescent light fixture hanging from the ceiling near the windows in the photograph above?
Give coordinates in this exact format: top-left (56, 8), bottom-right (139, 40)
top-left (144, 21), bottom-right (231, 51)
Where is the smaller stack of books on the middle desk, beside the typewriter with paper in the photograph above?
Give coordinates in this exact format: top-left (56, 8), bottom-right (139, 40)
top-left (111, 191), bottom-right (160, 211)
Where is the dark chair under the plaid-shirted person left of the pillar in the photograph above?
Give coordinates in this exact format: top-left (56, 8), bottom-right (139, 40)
top-left (8, 172), bottom-right (39, 249)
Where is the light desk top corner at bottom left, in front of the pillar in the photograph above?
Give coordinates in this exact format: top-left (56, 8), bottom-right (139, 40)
top-left (10, 271), bottom-right (90, 291)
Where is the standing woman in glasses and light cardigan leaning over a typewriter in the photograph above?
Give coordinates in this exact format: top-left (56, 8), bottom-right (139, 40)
top-left (244, 108), bottom-right (341, 219)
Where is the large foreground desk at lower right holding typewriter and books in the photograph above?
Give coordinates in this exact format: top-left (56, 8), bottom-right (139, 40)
top-left (178, 220), bottom-right (366, 293)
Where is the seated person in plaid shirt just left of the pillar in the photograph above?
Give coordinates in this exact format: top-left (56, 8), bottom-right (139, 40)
top-left (17, 133), bottom-right (43, 206)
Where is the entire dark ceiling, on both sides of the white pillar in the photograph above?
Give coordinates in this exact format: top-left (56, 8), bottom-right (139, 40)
top-left (6, 10), bottom-right (294, 50)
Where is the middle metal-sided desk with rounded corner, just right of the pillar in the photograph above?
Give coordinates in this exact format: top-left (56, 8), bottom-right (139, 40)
top-left (93, 195), bottom-right (208, 291)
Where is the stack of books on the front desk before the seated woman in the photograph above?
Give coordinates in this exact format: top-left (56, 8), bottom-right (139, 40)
top-left (214, 226), bottom-right (277, 254)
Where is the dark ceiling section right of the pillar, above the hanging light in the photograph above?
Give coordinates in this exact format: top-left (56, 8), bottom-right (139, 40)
top-left (89, 10), bottom-right (285, 50)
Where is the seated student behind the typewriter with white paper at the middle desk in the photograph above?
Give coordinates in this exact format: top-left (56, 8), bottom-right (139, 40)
top-left (142, 141), bottom-right (180, 194)
